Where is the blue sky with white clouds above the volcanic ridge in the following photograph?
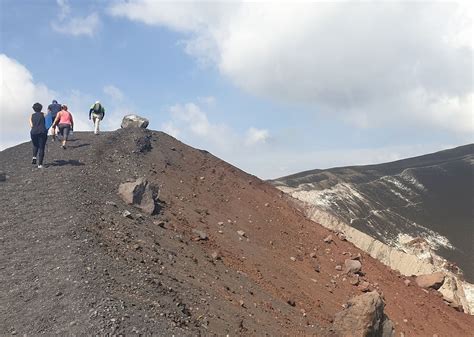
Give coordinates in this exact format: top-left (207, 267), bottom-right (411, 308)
top-left (0, 0), bottom-right (474, 179)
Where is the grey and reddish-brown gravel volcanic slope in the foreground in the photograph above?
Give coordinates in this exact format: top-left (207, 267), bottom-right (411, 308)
top-left (0, 129), bottom-right (474, 336)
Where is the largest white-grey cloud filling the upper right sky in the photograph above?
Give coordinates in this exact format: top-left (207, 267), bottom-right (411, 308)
top-left (110, 0), bottom-right (474, 133)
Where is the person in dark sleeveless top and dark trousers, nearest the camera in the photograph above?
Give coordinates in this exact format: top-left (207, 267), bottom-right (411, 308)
top-left (30, 103), bottom-right (48, 168)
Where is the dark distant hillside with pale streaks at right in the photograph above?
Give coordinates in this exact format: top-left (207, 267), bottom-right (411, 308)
top-left (272, 144), bottom-right (474, 282)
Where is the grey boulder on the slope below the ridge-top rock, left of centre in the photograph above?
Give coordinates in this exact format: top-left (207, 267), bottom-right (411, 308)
top-left (118, 178), bottom-right (157, 215)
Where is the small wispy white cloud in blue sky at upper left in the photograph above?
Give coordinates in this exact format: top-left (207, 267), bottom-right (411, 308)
top-left (51, 0), bottom-right (100, 37)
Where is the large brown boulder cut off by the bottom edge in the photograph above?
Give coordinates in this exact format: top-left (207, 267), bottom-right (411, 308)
top-left (333, 291), bottom-right (394, 337)
